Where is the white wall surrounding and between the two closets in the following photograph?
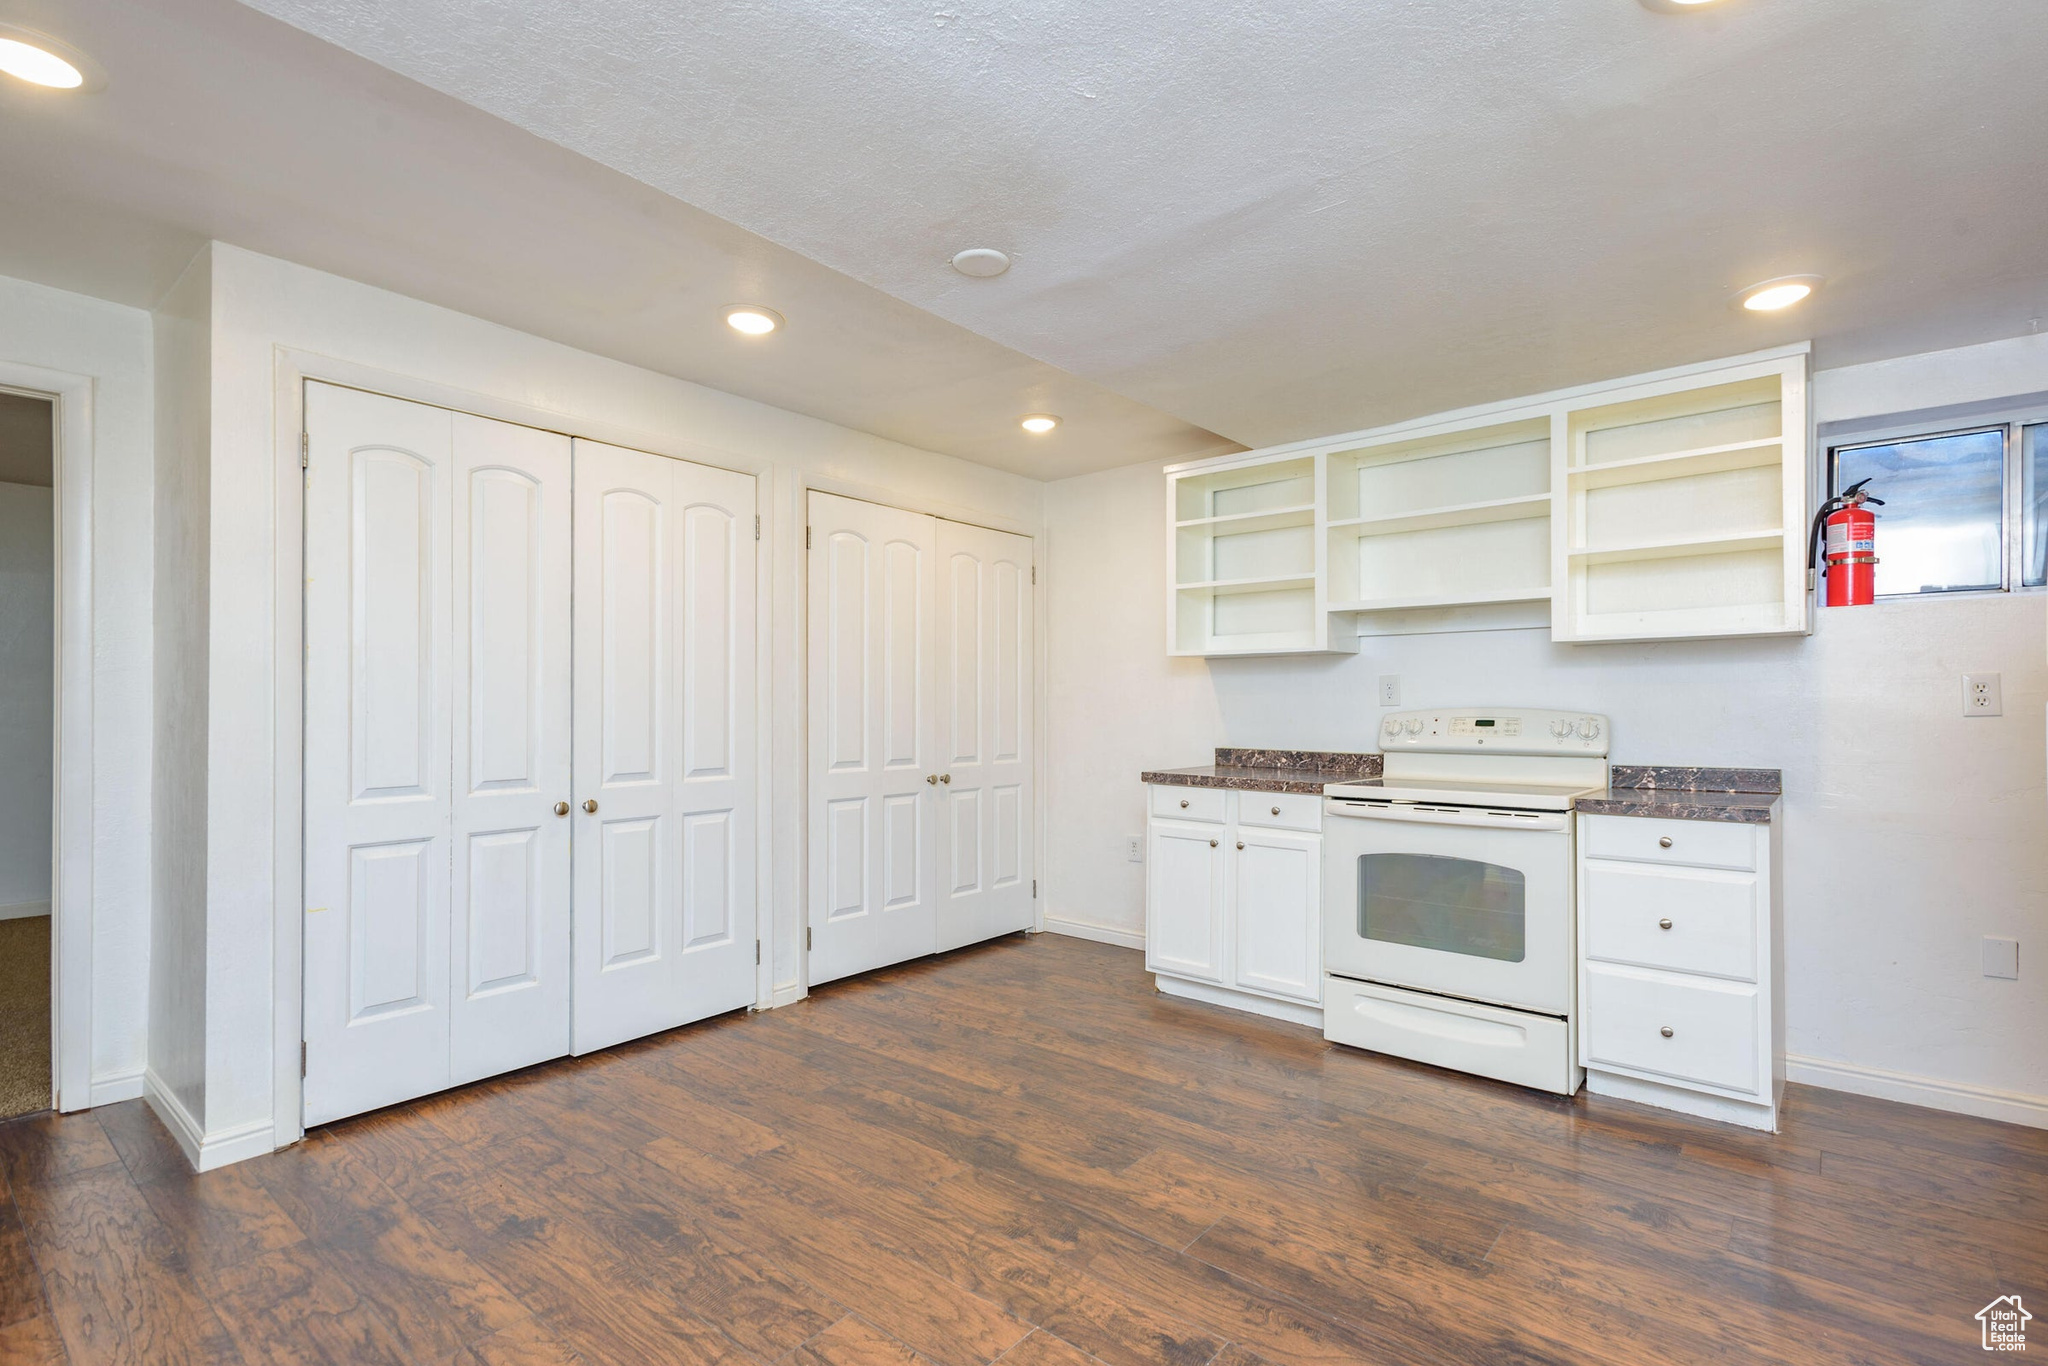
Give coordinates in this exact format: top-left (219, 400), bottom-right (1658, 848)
top-left (203, 242), bottom-right (1044, 1137)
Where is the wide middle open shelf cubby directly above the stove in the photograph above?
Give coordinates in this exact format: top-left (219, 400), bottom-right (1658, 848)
top-left (1325, 416), bottom-right (1550, 612)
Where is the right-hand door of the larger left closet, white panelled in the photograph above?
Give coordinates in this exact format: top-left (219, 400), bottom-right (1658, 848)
top-left (573, 440), bottom-right (756, 1053)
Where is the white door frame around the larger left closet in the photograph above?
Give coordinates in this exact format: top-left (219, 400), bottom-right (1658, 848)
top-left (272, 356), bottom-right (776, 1147)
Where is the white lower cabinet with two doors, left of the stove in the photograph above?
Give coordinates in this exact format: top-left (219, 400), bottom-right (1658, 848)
top-left (1145, 784), bottom-right (1323, 1024)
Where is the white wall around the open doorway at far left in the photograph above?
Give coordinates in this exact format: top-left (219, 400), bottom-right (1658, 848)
top-left (0, 276), bottom-right (152, 1100)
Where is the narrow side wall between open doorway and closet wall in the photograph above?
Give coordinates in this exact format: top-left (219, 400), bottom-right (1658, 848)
top-left (150, 248), bottom-right (213, 1126)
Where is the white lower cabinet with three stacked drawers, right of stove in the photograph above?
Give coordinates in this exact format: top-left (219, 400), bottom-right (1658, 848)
top-left (1579, 815), bottom-right (1784, 1128)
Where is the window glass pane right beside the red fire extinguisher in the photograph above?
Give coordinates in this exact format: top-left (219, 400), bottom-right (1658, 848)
top-left (1835, 428), bottom-right (2005, 594)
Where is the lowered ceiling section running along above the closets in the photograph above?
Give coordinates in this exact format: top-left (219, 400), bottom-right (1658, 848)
top-left (0, 0), bottom-right (1235, 477)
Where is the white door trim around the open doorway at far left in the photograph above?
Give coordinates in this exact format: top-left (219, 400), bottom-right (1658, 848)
top-left (0, 360), bottom-right (92, 1110)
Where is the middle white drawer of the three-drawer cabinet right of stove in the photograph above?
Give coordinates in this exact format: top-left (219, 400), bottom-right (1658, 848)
top-left (1579, 858), bottom-right (1757, 981)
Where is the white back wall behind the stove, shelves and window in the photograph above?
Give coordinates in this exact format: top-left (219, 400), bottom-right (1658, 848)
top-left (1047, 338), bottom-right (2048, 1122)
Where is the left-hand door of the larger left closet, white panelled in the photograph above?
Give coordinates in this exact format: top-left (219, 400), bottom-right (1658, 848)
top-left (305, 383), bottom-right (569, 1124)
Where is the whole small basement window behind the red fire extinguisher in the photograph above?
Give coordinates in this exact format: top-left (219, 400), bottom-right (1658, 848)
top-left (1827, 420), bottom-right (2048, 598)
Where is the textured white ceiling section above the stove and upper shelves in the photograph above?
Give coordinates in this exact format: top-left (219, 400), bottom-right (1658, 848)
top-left (232, 0), bottom-right (2048, 444)
